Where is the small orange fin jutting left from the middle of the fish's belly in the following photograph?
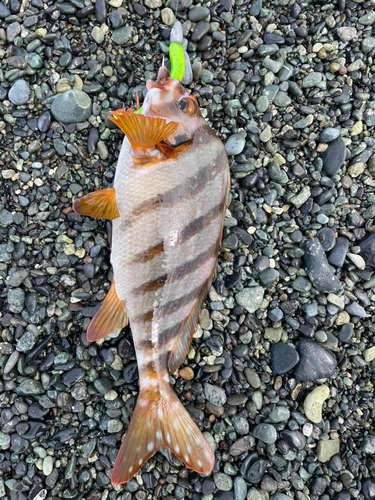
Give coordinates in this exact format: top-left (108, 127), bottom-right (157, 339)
top-left (73, 188), bottom-right (120, 220)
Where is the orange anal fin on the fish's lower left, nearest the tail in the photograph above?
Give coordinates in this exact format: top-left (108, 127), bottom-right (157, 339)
top-left (86, 281), bottom-right (128, 342)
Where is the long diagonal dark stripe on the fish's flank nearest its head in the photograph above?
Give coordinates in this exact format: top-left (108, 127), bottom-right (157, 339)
top-left (130, 150), bottom-right (227, 219)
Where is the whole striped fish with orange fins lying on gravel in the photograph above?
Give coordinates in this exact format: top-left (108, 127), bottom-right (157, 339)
top-left (73, 66), bottom-right (230, 484)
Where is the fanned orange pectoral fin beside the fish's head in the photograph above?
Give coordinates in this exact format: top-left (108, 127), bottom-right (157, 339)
top-left (109, 109), bottom-right (178, 151)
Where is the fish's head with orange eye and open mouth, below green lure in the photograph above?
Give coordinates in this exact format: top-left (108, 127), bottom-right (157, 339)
top-left (142, 66), bottom-right (202, 148)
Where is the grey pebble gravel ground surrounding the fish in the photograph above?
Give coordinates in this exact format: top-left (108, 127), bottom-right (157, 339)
top-left (0, 0), bottom-right (375, 500)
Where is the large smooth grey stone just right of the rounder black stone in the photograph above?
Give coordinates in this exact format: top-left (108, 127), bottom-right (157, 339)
top-left (294, 339), bottom-right (337, 382)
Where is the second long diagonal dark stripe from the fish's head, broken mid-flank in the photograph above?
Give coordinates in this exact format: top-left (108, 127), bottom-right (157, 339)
top-left (131, 195), bottom-right (227, 264)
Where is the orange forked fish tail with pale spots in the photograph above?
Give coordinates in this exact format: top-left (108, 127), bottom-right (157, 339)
top-left (111, 384), bottom-right (215, 484)
